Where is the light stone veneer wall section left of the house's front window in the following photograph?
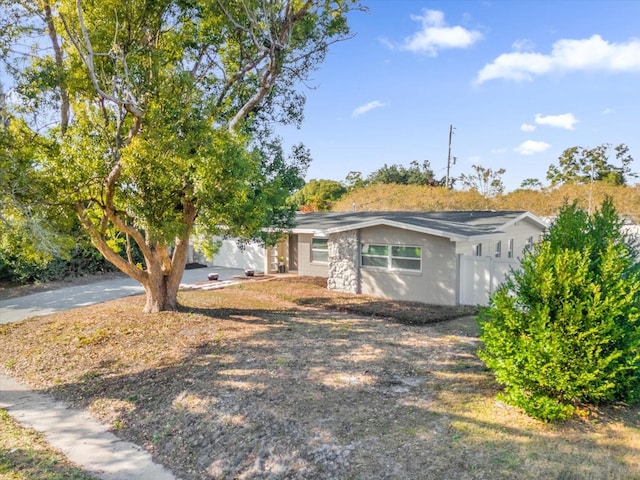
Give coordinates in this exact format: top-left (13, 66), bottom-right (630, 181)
top-left (327, 230), bottom-right (360, 293)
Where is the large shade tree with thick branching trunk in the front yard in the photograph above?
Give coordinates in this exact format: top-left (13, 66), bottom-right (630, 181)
top-left (0, 0), bottom-right (355, 312)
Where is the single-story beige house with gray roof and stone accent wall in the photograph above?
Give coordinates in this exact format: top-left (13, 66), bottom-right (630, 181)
top-left (213, 211), bottom-right (547, 305)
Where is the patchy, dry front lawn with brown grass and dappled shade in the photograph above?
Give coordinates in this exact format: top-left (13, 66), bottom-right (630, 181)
top-left (0, 278), bottom-right (640, 480)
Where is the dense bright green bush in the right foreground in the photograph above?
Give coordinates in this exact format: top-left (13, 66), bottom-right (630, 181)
top-left (479, 200), bottom-right (640, 421)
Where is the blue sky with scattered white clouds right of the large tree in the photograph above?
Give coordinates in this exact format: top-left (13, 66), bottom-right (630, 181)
top-left (282, 0), bottom-right (640, 191)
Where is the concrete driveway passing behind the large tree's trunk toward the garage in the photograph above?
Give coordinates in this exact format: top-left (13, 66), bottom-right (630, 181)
top-left (0, 267), bottom-right (244, 324)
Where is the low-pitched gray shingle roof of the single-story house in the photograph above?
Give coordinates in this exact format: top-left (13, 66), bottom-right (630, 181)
top-left (293, 210), bottom-right (544, 238)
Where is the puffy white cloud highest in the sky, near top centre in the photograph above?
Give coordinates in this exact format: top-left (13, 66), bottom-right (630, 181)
top-left (400, 10), bottom-right (482, 57)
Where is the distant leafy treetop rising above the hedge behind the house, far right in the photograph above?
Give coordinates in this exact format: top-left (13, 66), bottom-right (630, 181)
top-left (547, 143), bottom-right (636, 186)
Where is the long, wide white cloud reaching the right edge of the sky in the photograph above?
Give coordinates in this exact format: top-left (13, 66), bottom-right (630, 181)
top-left (476, 35), bottom-right (640, 83)
